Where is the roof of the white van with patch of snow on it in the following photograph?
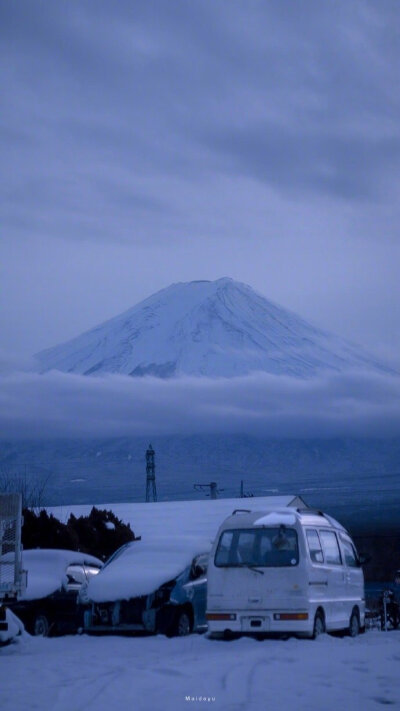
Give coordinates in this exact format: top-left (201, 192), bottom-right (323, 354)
top-left (222, 507), bottom-right (345, 531)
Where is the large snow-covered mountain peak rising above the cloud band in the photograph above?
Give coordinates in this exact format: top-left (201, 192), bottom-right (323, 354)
top-left (36, 278), bottom-right (390, 377)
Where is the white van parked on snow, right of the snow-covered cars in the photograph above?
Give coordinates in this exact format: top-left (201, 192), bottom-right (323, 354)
top-left (206, 508), bottom-right (365, 637)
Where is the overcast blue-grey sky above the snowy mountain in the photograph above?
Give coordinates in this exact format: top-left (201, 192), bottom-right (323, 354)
top-left (0, 0), bottom-right (400, 365)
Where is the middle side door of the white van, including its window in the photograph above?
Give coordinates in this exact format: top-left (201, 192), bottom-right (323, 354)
top-left (318, 529), bottom-right (348, 629)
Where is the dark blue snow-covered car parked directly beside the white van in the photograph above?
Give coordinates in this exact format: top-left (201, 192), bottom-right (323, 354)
top-left (84, 540), bottom-right (208, 636)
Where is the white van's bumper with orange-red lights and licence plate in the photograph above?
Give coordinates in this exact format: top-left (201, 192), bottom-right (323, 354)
top-left (206, 610), bottom-right (314, 635)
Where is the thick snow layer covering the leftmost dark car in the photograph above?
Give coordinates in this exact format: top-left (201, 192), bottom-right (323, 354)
top-left (15, 548), bottom-right (102, 600)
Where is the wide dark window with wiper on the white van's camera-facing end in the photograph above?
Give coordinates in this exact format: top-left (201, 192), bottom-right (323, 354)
top-left (214, 526), bottom-right (299, 568)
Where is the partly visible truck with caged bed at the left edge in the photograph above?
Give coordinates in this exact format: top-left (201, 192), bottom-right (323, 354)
top-left (0, 494), bottom-right (26, 643)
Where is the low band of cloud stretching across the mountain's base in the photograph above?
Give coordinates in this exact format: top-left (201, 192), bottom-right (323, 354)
top-left (0, 371), bottom-right (400, 439)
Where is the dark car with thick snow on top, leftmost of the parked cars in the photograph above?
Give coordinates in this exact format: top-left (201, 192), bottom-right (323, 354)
top-left (9, 548), bottom-right (103, 637)
